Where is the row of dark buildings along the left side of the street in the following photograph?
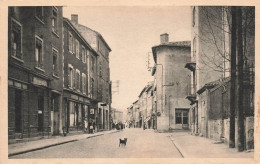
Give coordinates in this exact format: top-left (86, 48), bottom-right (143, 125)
top-left (8, 6), bottom-right (112, 142)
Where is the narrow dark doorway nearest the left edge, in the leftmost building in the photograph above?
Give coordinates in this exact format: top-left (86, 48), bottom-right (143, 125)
top-left (15, 90), bottom-right (22, 133)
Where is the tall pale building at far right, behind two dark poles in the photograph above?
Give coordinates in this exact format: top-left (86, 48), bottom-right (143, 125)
top-left (185, 6), bottom-right (255, 150)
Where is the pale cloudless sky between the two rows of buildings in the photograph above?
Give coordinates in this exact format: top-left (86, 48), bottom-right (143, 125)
top-left (63, 6), bottom-right (191, 111)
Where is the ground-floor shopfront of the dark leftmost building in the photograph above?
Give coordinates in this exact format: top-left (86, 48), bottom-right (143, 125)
top-left (8, 67), bottom-right (61, 142)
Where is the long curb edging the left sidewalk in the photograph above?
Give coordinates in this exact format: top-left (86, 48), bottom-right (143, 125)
top-left (8, 131), bottom-right (120, 157)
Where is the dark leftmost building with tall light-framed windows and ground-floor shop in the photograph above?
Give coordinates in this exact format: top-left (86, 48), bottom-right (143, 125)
top-left (8, 6), bottom-right (63, 141)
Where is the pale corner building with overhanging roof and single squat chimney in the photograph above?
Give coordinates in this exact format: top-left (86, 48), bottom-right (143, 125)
top-left (152, 34), bottom-right (190, 131)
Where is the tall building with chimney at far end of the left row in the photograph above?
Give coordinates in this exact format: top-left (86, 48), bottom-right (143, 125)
top-left (71, 15), bottom-right (112, 130)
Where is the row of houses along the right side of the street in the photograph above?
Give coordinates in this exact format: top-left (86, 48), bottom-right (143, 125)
top-left (128, 6), bottom-right (255, 149)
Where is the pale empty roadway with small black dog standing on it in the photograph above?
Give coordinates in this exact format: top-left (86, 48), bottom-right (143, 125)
top-left (11, 129), bottom-right (182, 158)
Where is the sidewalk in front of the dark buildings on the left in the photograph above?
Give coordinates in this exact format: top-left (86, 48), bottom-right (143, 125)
top-left (8, 130), bottom-right (120, 157)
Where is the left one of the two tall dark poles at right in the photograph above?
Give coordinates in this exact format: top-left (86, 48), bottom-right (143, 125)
top-left (229, 6), bottom-right (237, 148)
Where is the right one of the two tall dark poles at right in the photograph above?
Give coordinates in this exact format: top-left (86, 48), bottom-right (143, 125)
top-left (236, 7), bottom-right (245, 151)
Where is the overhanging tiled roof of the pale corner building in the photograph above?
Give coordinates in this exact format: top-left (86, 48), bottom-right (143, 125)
top-left (152, 41), bottom-right (191, 63)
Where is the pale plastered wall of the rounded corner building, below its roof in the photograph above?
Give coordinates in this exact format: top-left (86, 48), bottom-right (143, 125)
top-left (156, 46), bottom-right (190, 130)
